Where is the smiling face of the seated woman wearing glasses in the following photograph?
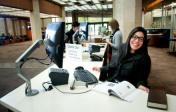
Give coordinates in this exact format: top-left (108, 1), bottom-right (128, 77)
top-left (130, 31), bottom-right (144, 53)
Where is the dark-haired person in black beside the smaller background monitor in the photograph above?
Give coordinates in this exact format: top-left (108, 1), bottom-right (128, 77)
top-left (64, 21), bottom-right (80, 44)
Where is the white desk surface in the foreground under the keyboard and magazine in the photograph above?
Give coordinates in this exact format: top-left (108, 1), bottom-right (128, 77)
top-left (0, 42), bottom-right (176, 112)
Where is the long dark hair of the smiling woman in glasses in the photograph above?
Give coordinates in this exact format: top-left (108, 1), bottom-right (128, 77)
top-left (126, 26), bottom-right (148, 53)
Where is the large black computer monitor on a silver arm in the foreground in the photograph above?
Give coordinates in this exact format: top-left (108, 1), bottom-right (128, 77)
top-left (44, 22), bottom-right (65, 68)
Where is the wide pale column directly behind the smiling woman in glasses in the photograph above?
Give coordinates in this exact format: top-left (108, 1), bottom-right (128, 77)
top-left (113, 0), bottom-right (142, 42)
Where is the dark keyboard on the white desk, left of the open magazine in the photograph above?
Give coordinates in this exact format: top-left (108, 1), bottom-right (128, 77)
top-left (74, 70), bottom-right (98, 84)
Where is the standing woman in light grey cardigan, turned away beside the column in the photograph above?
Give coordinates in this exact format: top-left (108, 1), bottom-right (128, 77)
top-left (106, 19), bottom-right (122, 61)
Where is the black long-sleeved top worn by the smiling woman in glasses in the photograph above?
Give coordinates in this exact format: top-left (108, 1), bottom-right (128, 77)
top-left (101, 44), bottom-right (151, 87)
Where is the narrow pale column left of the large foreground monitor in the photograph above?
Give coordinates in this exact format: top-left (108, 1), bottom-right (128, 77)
top-left (30, 0), bottom-right (42, 42)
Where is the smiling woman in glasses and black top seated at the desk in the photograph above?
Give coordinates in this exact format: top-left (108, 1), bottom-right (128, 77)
top-left (93, 27), bottom-right (151, 92)
